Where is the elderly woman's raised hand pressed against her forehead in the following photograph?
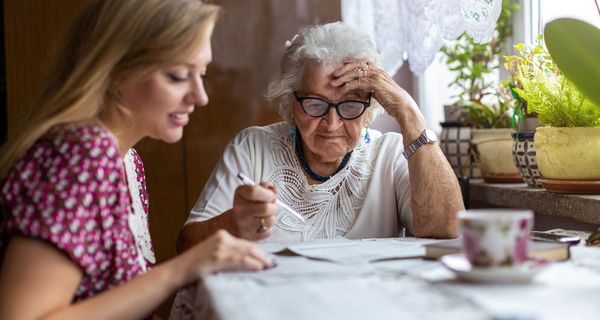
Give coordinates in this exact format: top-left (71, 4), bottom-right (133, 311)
top-left (330, 60), bottom-right (416, 117)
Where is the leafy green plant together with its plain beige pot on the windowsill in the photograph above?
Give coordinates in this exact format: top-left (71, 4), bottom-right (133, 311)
top-left (442, 1), bottom-right (522, 182)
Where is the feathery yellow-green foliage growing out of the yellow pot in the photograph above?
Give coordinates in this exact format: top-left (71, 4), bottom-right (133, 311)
top-left (505, 36), bottom-right (600, 127)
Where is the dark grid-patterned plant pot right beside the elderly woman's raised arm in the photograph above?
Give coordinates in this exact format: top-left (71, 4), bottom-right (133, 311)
top-left (440, 122), bottom-right (481, 178)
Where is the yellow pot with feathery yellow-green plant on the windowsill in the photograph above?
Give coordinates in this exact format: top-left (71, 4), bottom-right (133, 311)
top-left (513, 34), bottom-right (600, 191)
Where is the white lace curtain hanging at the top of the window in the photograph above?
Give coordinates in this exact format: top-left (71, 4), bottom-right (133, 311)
top-left (341, 0), bottom-right (502, 75)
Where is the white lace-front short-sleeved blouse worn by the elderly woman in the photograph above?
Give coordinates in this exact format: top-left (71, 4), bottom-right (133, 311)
top-left (186, 122), bottom-right (412, 243)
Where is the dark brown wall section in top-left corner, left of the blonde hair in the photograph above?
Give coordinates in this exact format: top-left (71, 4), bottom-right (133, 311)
top-left (4, 0), bottom-right (83, 136)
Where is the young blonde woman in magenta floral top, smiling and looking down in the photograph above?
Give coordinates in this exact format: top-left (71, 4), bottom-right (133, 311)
top-left (0, 0), bottom-right (276, 319)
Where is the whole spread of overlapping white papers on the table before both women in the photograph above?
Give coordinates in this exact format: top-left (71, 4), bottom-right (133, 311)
top-left (220, 237), bottom-right (446, 285)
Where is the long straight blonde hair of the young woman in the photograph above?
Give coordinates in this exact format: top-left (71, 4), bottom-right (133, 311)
top-left (0, 0), bottom-right (219, 180)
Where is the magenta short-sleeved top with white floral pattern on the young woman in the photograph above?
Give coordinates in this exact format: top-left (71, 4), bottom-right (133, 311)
top-left (0, 124), bottom-right (151, 301)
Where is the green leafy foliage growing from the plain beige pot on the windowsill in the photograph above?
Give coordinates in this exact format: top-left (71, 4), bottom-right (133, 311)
top-left (441, 1), bottom-right (519, 128)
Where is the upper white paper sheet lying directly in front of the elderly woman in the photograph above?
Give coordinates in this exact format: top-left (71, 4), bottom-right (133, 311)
top-left (287, 238), bottom-right (436, 264)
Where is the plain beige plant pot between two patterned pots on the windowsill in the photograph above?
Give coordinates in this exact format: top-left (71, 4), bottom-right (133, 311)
top-left (471, 129), bottom-right (523, 183)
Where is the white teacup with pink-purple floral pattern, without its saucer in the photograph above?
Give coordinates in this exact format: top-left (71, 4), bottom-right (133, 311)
top-left (458, 209), bottom-right (533, 267)
